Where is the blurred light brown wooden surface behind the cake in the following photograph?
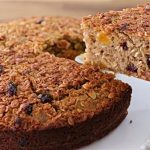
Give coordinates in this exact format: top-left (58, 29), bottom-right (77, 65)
top-left (0, 0), bottom-right (150, 20)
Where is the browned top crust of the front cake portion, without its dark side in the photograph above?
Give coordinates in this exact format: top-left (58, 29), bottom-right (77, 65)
top-left (0, 51), bottom-right (130, 130)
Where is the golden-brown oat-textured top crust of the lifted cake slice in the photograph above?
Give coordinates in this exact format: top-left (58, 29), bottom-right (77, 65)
top-left (83, 3), bottom-right (150, 37)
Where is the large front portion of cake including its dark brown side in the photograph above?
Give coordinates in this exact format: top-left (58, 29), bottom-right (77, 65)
top-left (0, 50), bottom-right (132, 150)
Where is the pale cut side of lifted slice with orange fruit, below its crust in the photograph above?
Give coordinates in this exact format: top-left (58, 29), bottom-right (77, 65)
top-left (84, 29), bottom-right (150, 80)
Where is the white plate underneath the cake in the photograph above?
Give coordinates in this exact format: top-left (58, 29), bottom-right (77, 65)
top-left (76, 56), bottom-right (150, 150)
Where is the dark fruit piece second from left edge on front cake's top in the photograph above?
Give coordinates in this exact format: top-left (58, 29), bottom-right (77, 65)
top-left (7, 81), bottom-right (17, 96)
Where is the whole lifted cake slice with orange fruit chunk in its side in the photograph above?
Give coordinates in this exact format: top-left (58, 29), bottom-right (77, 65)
top-left (82, 3), bottom-right (150, 81)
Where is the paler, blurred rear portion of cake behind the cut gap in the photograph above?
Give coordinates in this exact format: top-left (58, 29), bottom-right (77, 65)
top-left (0, 16), bottom-right (85, 59)
